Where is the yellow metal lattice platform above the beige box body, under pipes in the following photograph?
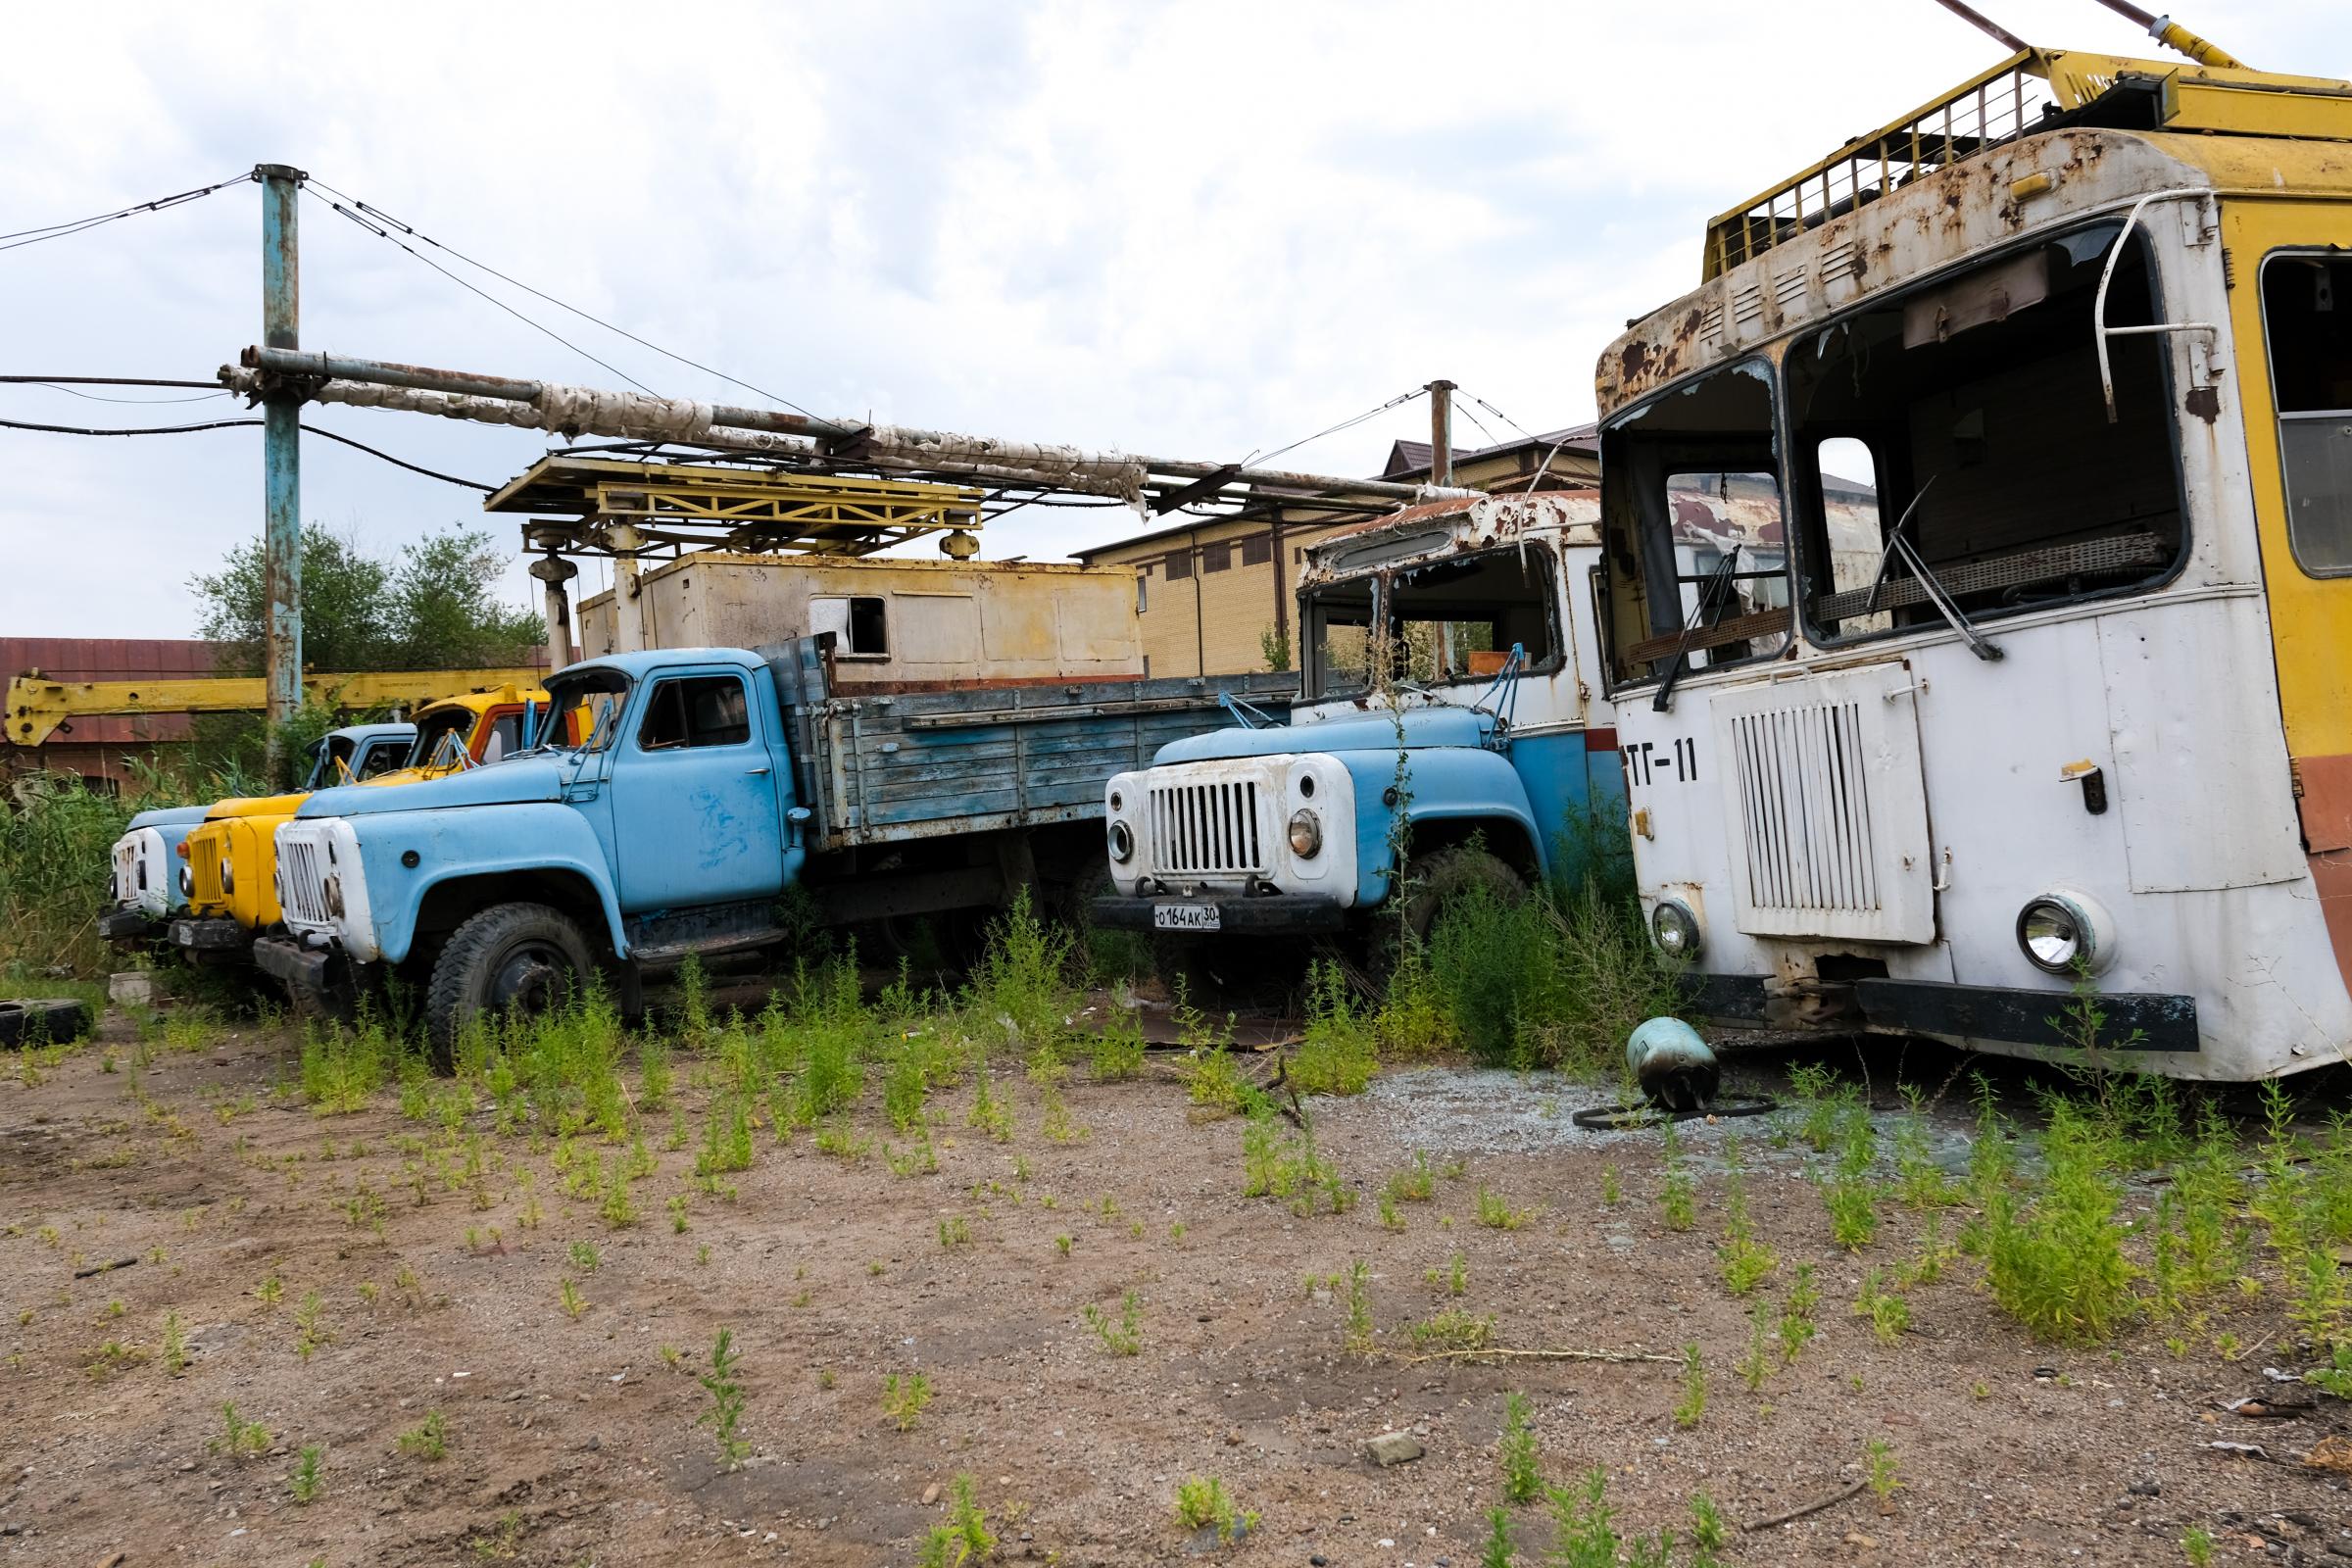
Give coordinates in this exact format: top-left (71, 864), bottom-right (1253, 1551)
top-left (482, 456), bottom-right (983, 555)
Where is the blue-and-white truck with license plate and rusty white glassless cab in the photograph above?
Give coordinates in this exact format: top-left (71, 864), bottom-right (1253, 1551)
top-left (1094, 491), bottom-right (1625, 938)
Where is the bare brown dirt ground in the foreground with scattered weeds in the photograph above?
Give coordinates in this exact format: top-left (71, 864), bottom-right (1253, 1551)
top-left (0, 1001), bottom-right (2352, 1568)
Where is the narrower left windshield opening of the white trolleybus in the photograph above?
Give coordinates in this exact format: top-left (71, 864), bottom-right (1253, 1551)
top-left (1601, 360), bottom-right (1789, 682)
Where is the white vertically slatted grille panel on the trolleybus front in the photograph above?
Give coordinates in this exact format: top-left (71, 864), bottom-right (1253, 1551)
top-left (1731, 701), bottom-right (1880, 912)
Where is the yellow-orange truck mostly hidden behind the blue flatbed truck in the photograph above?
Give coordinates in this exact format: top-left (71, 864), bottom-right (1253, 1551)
top-left (170, 686), bottom-right (548, 961)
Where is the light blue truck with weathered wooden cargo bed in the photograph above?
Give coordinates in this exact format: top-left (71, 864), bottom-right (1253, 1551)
top-left (254, 632), bottom-right (1296, 1057)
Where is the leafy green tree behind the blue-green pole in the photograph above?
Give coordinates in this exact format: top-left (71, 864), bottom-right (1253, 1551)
top-left (188, 526), bottom-right (546, 674)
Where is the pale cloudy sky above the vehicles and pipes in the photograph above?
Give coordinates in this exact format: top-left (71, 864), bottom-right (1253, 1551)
top-left (0, 0), bottom-right (2352, 637)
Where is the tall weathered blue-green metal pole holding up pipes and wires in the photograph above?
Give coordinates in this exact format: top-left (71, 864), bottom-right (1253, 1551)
top-left (254, 163), bottom-right (304, 764)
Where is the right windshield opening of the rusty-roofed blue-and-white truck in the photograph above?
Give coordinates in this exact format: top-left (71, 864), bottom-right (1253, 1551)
top-left (1386, 546), bottom-right (1559, 684)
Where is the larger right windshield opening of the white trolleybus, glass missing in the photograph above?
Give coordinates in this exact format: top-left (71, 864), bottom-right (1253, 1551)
top-left (1786, 223), bottom-right (2182, 642)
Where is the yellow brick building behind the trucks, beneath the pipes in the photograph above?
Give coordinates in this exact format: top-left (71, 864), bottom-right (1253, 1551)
top-left (1072, 425), bottom-right (1601, 674)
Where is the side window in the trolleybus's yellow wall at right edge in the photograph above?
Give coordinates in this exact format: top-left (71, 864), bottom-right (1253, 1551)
top-left (2263, 254), bottom-right (2352, 576)
